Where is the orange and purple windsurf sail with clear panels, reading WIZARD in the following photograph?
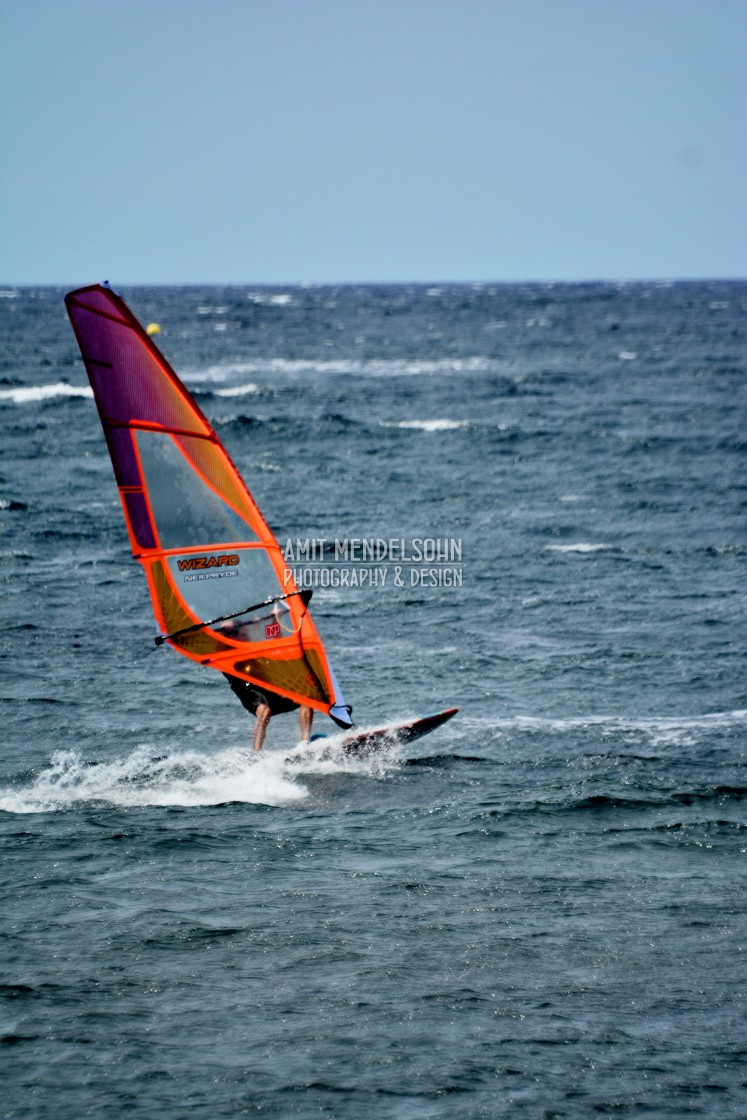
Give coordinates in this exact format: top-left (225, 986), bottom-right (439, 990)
top-left (65, 284), bottom-right (353, 727)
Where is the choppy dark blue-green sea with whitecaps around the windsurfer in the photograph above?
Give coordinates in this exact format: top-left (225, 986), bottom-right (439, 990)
top-left (0, 278), bottom-right (747, 1120)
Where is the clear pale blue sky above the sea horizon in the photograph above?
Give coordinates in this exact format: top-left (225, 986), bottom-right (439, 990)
top-left (0, 0), bottom-right (747, 284)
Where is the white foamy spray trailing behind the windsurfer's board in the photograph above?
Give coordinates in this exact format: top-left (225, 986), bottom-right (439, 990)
top-left (0, 736), bottom-right (394, 813)
